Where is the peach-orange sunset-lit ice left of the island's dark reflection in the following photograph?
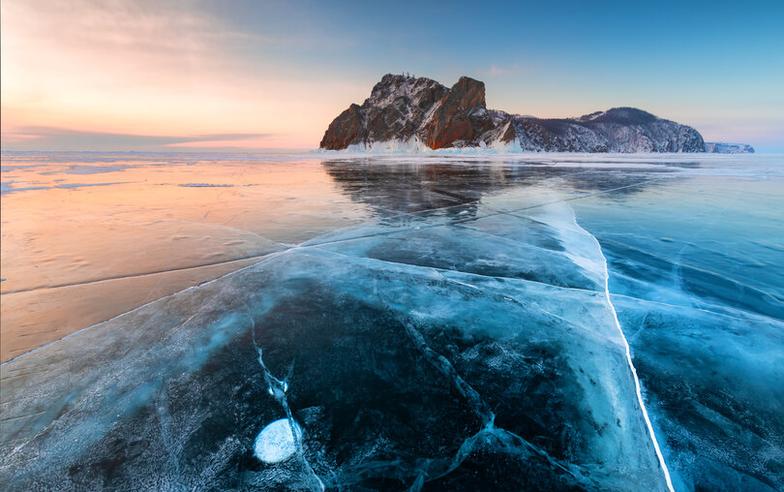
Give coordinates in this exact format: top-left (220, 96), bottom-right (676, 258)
top-left (0, 158), bottom-right (369, 360)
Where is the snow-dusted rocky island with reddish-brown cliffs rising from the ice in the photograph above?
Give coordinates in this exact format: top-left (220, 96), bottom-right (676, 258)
top-left (320, 74), bottom-right (753, 152)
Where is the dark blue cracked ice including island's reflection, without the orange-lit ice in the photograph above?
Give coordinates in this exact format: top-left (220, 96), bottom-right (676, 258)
top-left (0, 152), bottom-right (784, 491)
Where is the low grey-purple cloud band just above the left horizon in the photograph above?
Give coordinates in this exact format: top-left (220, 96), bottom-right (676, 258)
top-left (2, 126), bottom-right (274, 150)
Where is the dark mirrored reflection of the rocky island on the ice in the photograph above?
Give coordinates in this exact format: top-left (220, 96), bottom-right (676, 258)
top-left (322, 159), bottom-right (676, 215)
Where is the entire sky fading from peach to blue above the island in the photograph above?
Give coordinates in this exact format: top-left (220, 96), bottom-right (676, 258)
top-left (0, 0), bottom-right (784, 152)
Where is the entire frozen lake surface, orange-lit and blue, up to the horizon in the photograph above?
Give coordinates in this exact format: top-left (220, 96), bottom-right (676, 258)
top-left (0, 153), bottom-right (784, 491)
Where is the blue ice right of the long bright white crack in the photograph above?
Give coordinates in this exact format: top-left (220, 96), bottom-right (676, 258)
top-left (575, 174), bottom-right (784, 490)
